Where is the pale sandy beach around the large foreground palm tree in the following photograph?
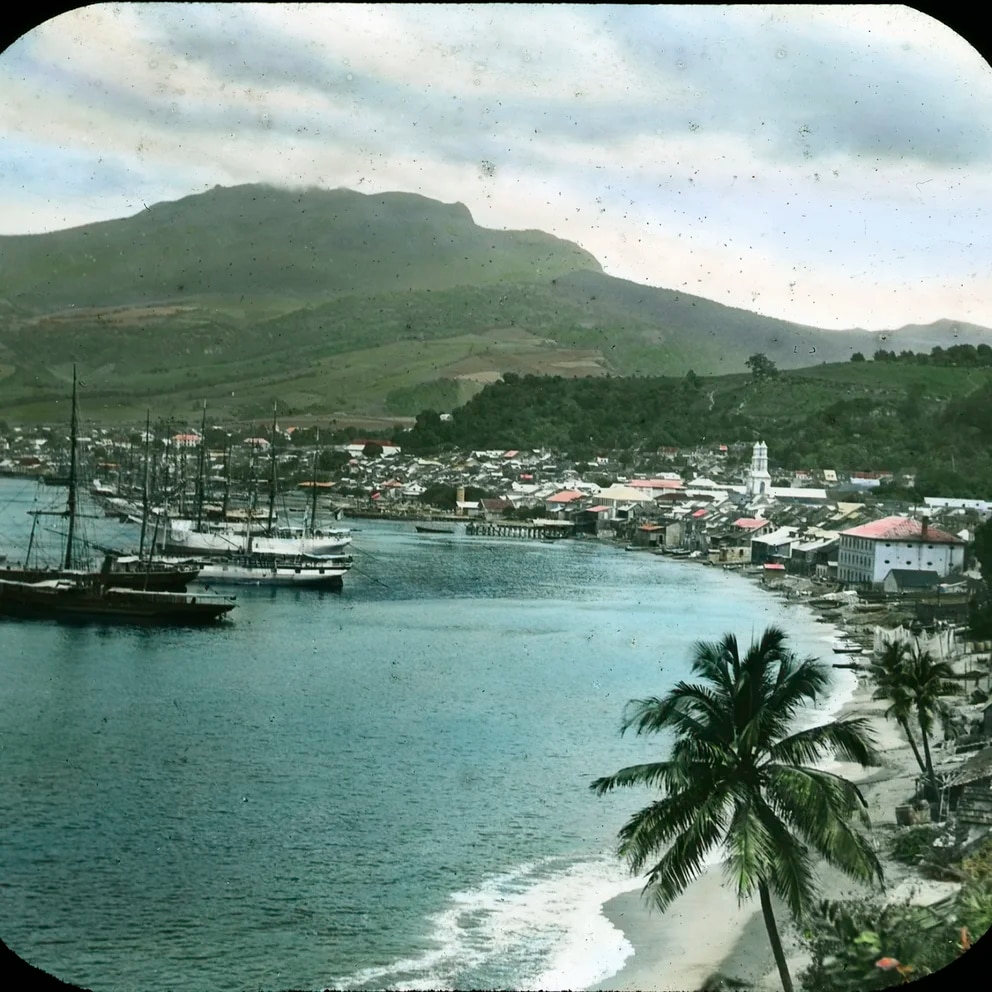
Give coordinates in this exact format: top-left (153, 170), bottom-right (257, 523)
top-left (592, 568), bottom-right (918, 992)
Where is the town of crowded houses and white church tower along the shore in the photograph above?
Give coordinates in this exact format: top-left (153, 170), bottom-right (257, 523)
top-left (0, 420), bottom-right (992, 593)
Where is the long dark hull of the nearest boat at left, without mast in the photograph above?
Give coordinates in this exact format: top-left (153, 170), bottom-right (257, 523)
top-left (0, 579), bottom-right (235, 626)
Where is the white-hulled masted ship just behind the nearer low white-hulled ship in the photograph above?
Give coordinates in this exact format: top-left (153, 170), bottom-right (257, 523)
top-left (164, 407), bottom-right (352, 558)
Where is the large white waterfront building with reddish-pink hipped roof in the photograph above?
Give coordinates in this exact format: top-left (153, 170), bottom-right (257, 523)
top-left (837, 517), bottom-right (965, 585)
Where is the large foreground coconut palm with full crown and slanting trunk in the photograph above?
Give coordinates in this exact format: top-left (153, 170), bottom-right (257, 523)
top-left (591, 627), bottom-right (882, 992)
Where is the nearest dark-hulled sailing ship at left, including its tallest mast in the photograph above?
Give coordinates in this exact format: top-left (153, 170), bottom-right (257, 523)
top-left (0, 366), bottom-right (236, 625)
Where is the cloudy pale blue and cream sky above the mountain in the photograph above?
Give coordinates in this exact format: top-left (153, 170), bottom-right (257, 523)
top-left (0, 3), bottom-right (992, 330)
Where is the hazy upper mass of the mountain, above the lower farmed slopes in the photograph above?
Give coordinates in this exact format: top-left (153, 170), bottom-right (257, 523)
top-left (0, 185), bottom-right (600, 312)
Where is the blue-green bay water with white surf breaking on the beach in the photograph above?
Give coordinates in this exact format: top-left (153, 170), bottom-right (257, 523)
top-left (0, 479), bottom-right (853, 992)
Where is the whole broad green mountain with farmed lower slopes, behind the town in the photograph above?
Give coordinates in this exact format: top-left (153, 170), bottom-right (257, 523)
top-left (0, 185), bottom-right (992, 419)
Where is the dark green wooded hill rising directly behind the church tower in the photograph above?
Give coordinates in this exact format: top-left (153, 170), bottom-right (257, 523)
top-left (403, 362), bottom-right (992, 498)
